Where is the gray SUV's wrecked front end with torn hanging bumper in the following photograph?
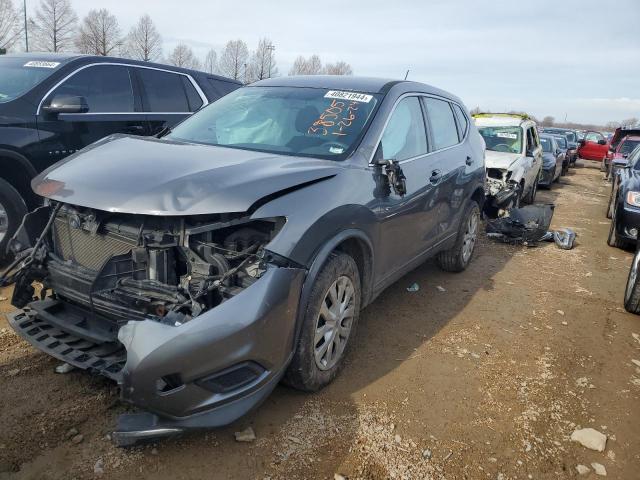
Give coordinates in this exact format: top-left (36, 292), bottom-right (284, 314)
top-left (5, 202), bottom-right (306, 444)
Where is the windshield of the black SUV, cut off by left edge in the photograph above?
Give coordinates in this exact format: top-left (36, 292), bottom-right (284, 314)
top-left (0, 56), bottom-right (60, 103)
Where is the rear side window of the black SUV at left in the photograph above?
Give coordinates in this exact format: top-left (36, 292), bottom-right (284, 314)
top-left (138, 68), bottom-right (202, 113)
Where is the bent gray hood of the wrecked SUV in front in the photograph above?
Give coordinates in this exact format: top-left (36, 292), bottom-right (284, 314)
top-left (31, 135), bottom-right (343, 215)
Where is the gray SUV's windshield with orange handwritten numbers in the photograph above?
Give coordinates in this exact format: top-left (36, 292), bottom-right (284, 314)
top-left (167, 87), bottom-right (379, 159)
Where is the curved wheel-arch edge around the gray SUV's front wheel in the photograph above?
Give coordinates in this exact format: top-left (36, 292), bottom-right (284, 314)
top-left (293, 229), bottom-right (374, 349)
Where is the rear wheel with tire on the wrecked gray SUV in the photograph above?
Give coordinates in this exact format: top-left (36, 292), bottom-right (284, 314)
top-left (436, 200), bottom-right (480, 272)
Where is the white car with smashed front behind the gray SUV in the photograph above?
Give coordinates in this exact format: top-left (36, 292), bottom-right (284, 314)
top-left (473, 113), bottom-right (542, 211)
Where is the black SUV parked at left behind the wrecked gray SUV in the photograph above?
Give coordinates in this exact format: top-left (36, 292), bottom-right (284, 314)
top-left (0, 54), bottom-right (241, 260)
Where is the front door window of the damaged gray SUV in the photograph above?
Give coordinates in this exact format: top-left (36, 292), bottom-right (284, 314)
top-left (380, 97), bottom-right (427, 161)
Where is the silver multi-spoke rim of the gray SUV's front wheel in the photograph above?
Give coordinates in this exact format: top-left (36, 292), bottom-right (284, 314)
top-left (313, 275), bottom-right (355, 370)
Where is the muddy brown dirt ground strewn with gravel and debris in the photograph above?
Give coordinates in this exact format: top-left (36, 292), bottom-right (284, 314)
top-left (0, 162), bottom-right (640, 480)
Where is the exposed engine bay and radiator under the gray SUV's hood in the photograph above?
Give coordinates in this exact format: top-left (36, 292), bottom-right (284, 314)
top-left (6, 203), bottom-right (285, 325)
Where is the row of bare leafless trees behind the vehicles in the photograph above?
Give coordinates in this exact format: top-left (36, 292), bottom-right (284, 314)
top-left (0, 0), bottom-right (353, 83)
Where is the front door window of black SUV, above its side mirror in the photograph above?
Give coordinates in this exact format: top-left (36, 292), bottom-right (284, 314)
top-left (49, 65), bottom-right (134, 113)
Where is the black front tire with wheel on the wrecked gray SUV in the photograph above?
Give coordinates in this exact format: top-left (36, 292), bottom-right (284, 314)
top-left (283, 253), bottom-right (362, 392)
